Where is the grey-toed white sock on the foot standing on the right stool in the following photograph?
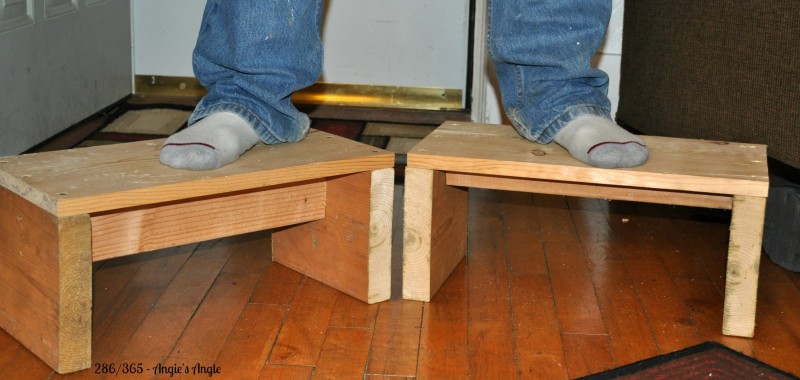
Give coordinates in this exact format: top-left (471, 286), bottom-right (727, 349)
top-left (553, 115), bottom-right (649, 168)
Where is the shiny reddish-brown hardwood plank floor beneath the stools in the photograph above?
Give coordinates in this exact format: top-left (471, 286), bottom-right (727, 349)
top-left (0, 186), bottom-right (800, 380)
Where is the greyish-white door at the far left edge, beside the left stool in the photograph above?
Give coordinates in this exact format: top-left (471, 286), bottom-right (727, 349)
top-left (0, 0), bottom-right (132, 156)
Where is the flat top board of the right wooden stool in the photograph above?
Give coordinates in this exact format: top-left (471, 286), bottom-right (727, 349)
top-left (408, 122), bottom-right (769, 197)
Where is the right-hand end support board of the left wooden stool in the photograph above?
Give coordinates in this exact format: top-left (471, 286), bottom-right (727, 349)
top-left (272, 169), bottom-right (394, 303)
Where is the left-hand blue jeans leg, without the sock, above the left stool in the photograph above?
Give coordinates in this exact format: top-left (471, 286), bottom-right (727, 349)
top-left (189, 0), bottom-right (322, 144)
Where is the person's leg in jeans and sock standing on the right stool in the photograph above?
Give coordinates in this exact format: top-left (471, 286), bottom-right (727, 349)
top-left (489, 0), bottom-right (648, 167)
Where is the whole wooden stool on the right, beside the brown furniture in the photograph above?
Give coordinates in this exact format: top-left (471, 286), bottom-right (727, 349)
top-left (403, 122), bottom-right (769, 337)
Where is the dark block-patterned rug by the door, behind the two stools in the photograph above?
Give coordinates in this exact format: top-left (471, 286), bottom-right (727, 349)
top-left (75, 102), bottom-right (435, 181)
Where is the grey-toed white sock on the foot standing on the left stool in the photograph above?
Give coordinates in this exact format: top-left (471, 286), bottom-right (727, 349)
top-left (161, 112), bottom-right (261, 170)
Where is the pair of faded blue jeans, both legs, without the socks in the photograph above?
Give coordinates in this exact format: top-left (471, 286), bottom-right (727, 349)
top-left (189, 0), bottom-right (611, 144)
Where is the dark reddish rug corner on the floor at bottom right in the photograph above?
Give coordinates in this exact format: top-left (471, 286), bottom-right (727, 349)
top-left (582, 342), bottom-right (798, 380)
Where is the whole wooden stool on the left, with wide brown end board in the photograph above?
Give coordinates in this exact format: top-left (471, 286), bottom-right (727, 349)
top-left (0, 130), bottom-right (394, 373)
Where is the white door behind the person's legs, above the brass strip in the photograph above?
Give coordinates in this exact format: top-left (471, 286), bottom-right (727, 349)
top-left (131, 0), bottom-right (470, 108)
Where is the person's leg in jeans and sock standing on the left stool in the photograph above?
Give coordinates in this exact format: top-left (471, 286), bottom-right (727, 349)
top-left (161, 0), bottom-right (322, 170)
